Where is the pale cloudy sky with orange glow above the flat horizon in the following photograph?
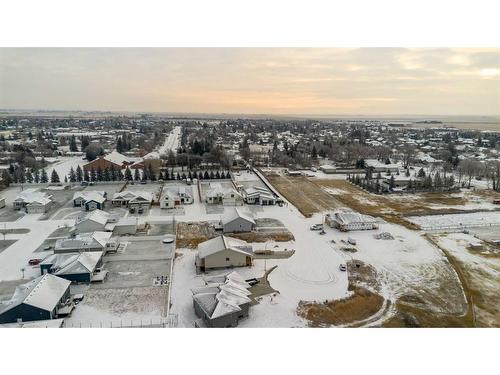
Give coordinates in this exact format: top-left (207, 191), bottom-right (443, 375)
top-left (0, 48), bottom-right (500, 116)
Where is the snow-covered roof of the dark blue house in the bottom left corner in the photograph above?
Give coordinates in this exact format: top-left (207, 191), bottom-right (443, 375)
top-left (0, 274), bottom-right (71, 313)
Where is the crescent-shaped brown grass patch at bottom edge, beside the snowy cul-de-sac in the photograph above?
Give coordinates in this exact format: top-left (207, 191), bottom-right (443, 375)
top-left (298, 287), bottom-right (384, 326)
